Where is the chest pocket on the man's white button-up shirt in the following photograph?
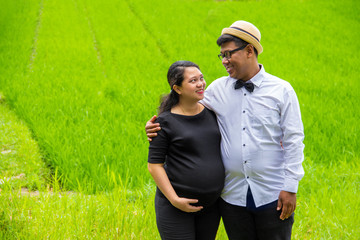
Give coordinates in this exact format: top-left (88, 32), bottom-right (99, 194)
top-left (251, 108), bottom-right (281, 140)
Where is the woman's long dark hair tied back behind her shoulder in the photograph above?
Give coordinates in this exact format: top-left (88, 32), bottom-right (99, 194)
top-left (158, 61), bottom-right (200, 114)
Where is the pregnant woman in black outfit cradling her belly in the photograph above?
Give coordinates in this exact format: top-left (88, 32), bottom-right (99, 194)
top-left (148, 61), bottom-right (225, 240)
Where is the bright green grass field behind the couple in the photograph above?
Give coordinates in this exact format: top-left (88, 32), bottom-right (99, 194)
top-left (0, 0), bottom-right (360, 240)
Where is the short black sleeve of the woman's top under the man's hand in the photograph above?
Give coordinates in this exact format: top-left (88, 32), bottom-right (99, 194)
top-left (148, 117), bottom-right (169, 163)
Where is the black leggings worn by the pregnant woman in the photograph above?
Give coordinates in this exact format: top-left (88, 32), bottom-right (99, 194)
top-left (155, 193), bottom-right (220, 240)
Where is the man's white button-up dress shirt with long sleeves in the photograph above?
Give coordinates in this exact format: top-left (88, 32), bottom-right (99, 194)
top-left (202, 65), bottom-right (304, 207)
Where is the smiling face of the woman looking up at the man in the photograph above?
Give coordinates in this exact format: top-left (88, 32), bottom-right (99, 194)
top-left (175, 67), bottom-right (206, 102)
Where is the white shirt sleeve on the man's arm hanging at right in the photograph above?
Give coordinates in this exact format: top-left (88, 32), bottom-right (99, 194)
top-left (280, 88), bottom-right (305, 193)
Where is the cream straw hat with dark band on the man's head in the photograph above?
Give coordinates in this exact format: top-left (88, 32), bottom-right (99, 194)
top-left (221, 21), bottom-right (263, 54)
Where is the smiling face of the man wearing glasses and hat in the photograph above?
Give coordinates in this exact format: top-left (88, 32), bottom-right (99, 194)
top-left (220, 42), bottom-right (249, 81)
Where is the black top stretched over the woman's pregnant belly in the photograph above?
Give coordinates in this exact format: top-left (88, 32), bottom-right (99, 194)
top-left (148, 108), bottom-right (225, 207)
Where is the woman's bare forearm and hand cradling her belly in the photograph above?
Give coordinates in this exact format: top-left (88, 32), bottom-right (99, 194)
top-left (148, 163), bottom-right (203, 212)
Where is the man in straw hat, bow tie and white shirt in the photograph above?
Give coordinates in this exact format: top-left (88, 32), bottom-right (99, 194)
top-left (146, 21), bottom-right (304, 240)
